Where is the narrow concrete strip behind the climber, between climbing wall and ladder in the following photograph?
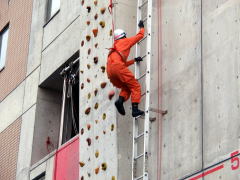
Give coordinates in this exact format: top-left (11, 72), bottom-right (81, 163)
top-left (114, 0), bottom-right (137, 179)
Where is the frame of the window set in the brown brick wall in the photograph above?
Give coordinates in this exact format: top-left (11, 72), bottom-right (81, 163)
top-left (0, 23), bottom-right (9, 72)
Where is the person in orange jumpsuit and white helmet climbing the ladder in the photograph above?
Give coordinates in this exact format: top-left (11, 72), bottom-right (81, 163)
top-left (107, 21), bottom-right (144, 117)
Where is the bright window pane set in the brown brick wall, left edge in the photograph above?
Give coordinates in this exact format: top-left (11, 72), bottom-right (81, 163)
top-left (0, 25), bottom-right (9, 71)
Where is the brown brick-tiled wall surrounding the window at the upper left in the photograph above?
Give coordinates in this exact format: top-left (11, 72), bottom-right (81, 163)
top-left (0, 0), bottom-right (32, 101)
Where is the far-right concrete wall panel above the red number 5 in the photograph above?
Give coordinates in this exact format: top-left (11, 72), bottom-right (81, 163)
top-left (203, 0), bottom-right (240, 170)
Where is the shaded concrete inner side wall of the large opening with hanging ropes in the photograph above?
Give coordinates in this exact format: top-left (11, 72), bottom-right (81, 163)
top-left (31, 88), bottom-right (61, 164)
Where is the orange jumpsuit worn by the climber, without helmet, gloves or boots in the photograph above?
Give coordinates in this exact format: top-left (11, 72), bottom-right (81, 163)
top-left (107, 28), bottom-right (144, 103)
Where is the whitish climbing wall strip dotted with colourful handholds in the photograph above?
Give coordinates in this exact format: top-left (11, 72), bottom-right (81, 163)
top-left (79, 0), bottom-right (117, 180)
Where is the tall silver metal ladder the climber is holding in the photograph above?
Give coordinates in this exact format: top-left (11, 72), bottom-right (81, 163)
top-left (132, 0), bottom-right (152, 180)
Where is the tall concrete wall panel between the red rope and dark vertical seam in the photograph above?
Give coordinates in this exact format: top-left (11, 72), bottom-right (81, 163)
top-left (159, 0), bottom-right (202, 180)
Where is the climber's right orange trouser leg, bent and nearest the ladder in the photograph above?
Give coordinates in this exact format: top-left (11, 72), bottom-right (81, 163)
top-left (120, 67), bottom-right (141, 103)
